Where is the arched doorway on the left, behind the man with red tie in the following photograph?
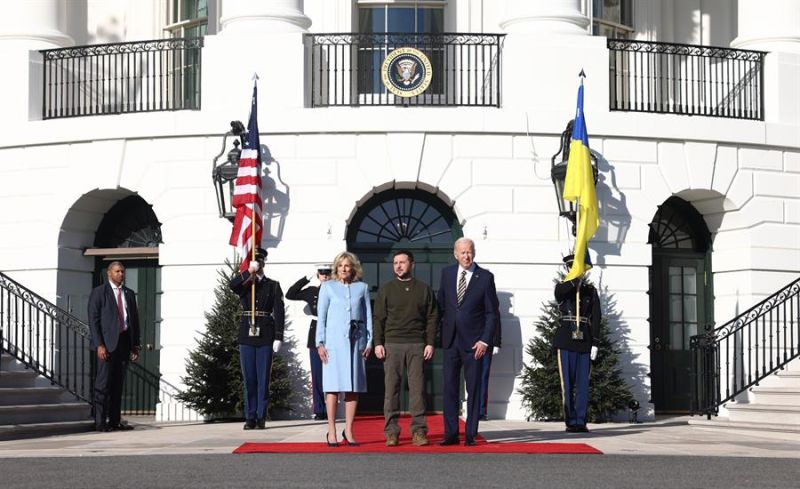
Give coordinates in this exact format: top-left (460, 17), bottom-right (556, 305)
top-left (85, 195), bottom-right (161, 414)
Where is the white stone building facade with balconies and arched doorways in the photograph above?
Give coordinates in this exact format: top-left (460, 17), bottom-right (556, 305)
top-left (0, 0), bottom-right (800, 419)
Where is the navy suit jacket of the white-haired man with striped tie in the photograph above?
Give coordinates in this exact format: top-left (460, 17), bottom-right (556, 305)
top-left (437, 264), bottom-right (500, 350)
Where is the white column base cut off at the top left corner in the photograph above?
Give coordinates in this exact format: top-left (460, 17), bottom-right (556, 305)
top-left (0, 0), bottom-right (73, 50)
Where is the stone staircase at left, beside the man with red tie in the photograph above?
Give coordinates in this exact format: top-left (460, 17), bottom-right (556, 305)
top-left (0, 353), bottom-right (94, 440)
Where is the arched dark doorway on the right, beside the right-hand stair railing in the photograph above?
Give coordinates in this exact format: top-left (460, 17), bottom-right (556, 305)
top-left (648, 196), bottom-right (714, 413)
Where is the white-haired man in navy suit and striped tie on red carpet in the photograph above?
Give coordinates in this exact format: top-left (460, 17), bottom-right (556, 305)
top-left (437, 238), bottom-right (499, 446)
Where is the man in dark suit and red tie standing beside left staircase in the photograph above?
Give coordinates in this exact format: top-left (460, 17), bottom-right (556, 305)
top-left (89, 261), bottom-right (141, 431)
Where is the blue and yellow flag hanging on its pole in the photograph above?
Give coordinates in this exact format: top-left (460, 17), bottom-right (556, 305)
top-left (564, 79), bottom-right (600, 281)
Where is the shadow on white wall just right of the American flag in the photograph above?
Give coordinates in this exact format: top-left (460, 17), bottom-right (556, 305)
top-left (261, 144), bottom-right (290, 248)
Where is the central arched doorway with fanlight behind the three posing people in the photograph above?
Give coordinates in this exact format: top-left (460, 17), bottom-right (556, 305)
top-left (347, 189), bottom-right (462, 413)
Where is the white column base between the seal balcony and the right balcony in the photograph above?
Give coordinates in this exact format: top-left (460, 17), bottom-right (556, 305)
top-left (500, 0), bottom-right (589, 36)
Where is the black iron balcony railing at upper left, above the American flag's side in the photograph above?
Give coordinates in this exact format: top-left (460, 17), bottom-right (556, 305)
top-left (40, 38), bottom-right (203, 119)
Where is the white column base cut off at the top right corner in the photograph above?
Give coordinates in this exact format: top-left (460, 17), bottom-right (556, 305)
top-left (731, 0), bottom-right (800, 54)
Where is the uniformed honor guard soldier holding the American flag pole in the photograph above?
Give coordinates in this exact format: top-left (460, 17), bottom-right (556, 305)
top-left (230, 248), bottom-right (285, 430)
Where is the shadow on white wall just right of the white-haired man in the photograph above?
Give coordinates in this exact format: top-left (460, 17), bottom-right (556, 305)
top-left (487, 292), bottom-right (524, 419)
